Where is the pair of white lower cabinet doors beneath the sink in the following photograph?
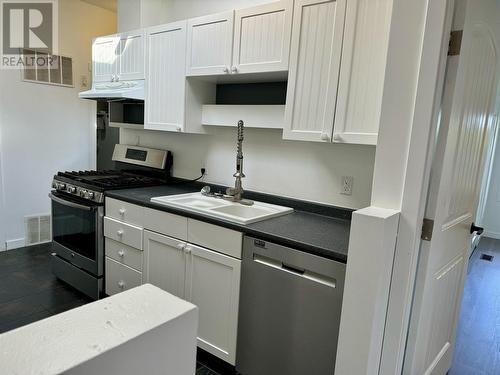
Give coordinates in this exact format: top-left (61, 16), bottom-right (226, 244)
top-left (144, 230), bottom-right (241, 365)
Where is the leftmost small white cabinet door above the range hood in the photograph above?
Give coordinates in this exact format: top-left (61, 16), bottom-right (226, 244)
top-left (92, 35), bottom-right (120, 82)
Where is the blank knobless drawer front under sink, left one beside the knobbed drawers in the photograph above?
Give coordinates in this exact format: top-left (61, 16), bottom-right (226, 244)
top-left (144, 208), bottom-right (187, 241)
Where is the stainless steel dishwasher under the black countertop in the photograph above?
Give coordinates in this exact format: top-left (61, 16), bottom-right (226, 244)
top-left (236, 237), bottom-right (345, 375)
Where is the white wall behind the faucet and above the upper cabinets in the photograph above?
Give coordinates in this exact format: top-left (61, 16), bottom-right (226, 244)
top-left (118, 0), bottom-right (375, 208)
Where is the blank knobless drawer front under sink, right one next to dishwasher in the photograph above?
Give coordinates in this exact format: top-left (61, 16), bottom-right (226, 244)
top-left (187, 219), bottom-right (243, 259)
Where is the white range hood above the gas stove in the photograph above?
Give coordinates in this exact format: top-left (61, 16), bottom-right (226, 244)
top-left (78, 80), bottom-right (144, 100)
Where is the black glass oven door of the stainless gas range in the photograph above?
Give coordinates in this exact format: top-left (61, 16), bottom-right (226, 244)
top-left (49, 191), bottom-right (104, 277)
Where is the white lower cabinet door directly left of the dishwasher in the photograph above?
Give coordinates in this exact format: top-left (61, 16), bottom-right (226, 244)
top-left (186, 244), bottom-right (241, 365)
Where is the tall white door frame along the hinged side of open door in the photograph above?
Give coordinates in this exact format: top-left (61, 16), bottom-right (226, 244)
top-left (378, 0), bottom-right (500, 375)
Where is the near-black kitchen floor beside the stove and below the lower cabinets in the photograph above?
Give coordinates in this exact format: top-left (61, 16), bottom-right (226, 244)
top-left (0, 244), bottom-right (224, 375)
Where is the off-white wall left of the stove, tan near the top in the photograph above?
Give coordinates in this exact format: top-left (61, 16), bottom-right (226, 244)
top-left (0, 0), bottom-right (116, 253)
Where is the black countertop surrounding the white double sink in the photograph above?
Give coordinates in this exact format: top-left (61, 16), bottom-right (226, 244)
top-left (106, 183), bottom-right (352, 262)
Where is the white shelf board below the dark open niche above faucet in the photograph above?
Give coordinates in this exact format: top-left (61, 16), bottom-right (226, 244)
top-left (202, 104), bottom-right (285, 129)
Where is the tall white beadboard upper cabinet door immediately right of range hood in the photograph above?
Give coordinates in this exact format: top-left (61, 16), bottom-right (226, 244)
top-left (144, 21), bottom-right (186, 131)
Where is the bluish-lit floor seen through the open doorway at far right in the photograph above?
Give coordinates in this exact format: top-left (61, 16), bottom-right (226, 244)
top-left (448, 238), bottom-right (500, 375)
